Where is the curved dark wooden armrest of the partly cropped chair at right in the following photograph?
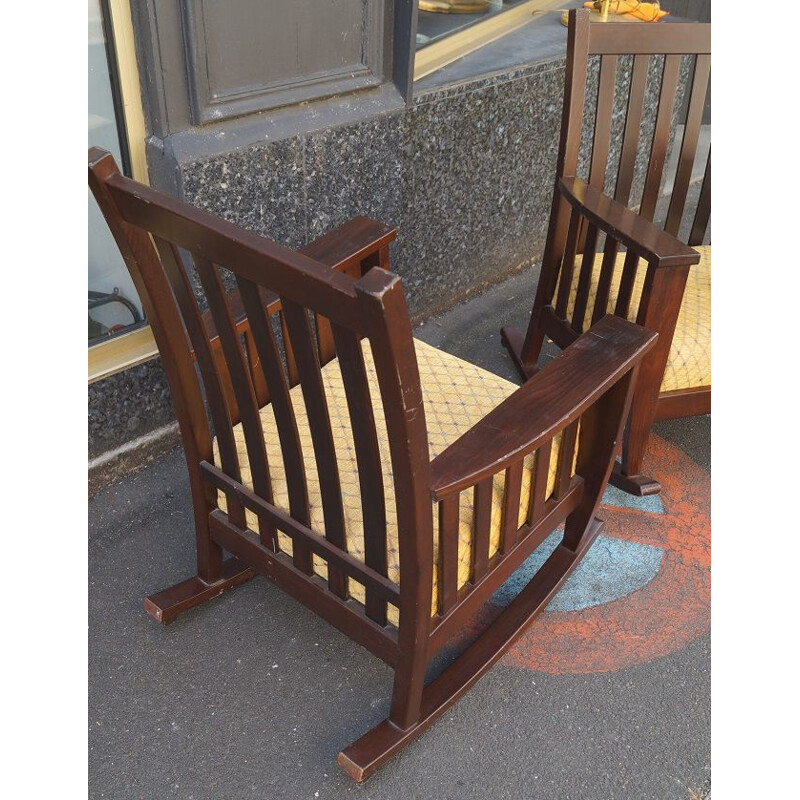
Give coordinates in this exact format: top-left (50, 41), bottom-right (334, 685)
top-left (559, 178), bottom-right (700, 267)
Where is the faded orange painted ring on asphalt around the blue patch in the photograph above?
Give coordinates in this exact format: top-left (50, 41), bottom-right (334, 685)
top-left (501, 436), bottom-right (711, 675)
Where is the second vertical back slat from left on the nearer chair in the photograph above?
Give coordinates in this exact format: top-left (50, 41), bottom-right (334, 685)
top-left (194, 254), bottom-right (277, 550)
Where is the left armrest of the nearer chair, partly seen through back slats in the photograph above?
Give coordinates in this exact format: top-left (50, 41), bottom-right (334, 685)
top-left (202, 217), bottom-right (397, 340)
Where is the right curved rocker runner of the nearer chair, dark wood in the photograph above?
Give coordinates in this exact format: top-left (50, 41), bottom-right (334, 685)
top-left (337, 520), bottom-right (601, 783)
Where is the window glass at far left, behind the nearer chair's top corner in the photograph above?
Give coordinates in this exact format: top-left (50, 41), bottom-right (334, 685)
top-left (89, 0), bottom-right (143, 344)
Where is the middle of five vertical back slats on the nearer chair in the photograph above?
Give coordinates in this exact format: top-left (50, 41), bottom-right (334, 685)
top-left (236, 275), bottom-right (314, 575)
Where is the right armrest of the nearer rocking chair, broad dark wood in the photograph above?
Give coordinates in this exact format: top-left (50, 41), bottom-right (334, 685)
top-left (431, 314), bottom-right (658, 501)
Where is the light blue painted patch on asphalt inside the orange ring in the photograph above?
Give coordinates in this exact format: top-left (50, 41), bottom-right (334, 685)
top-left (491, 532), bottom-right (664, 611)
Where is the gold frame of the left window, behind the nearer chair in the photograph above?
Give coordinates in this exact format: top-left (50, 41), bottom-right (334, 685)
top-left (89, 0), bottom-right (158, 383)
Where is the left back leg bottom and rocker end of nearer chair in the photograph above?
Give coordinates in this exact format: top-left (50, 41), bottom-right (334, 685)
top-left (144, 487), bottom-right (255, 625)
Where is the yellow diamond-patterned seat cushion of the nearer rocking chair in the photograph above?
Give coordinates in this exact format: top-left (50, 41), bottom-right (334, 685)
top-left (214, 340), bottom-right (560, 624)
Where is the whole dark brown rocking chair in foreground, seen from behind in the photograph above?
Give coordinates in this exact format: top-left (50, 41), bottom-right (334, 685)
top-left (89, 148), bottom-right (657, 781)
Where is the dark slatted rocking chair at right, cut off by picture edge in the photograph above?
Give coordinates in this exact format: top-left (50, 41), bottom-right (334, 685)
top-left (502, 9), bottom-right (711, 495)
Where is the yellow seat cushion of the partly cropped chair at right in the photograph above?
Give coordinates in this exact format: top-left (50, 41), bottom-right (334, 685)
top-left (567, 245), bottom-right (711, 392)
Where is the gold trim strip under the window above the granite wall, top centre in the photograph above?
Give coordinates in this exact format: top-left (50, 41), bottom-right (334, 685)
top-left (414, 0), bottom-right (563, 81)
